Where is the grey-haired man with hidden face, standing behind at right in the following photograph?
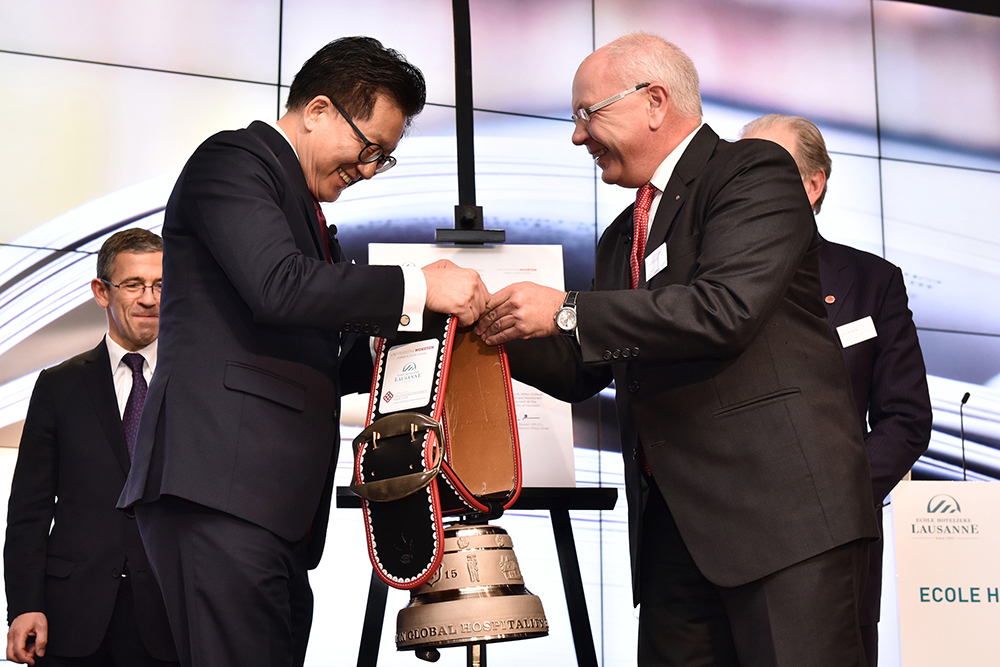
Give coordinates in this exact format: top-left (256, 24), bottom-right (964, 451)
top-left (743, 114), bottom-right (933, 667)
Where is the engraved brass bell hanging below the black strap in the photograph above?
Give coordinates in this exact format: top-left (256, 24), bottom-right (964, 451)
top-left (396, 524), bottom-right (549, 660)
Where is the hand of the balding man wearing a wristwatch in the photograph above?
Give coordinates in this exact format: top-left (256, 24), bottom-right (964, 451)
top-left (475, 283), bottom-right (566, 345)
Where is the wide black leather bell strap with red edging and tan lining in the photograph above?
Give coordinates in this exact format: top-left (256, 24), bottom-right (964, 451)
top-left (351, 314), bottom-right (521, 589)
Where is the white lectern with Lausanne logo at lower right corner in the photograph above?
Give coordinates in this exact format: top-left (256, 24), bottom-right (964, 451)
top-left (892, 482), bottom-right (1000, 667)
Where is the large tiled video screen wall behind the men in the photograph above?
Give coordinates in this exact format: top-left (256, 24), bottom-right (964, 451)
top-left (0, 0), bottom-right (1000, 665)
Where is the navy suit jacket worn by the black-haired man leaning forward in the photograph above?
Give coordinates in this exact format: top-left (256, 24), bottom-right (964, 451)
top-left (120, 122), bottom-right (403, 565)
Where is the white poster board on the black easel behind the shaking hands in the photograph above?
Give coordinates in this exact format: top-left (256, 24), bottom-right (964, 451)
top-left (368, 243), bottom-right (576, 487)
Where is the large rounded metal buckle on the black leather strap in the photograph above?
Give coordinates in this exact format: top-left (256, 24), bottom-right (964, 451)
top-left (350, 412), bottom-right (444, 503)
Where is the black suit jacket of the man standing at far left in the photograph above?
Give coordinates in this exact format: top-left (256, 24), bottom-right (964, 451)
top-left (4, 341), bottom-right (177, 660)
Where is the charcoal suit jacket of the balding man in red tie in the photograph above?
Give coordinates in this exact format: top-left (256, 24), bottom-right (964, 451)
top-left (508, 126), bottom-right (878, 599)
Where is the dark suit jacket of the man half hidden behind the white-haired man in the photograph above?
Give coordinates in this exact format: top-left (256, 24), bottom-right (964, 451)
top-left (819, 240), bottom-right (932, 624)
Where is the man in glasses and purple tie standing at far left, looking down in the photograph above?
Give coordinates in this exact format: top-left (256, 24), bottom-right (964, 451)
top-left (4, 229), bottom-right (177, 667)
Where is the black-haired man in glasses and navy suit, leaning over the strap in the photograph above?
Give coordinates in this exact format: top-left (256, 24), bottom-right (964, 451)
top-left (119, 37), bottom-right (488, 667)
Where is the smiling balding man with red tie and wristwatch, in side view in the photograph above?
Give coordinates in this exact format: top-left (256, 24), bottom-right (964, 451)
top-left (477, 34), bottom-right (878, 667)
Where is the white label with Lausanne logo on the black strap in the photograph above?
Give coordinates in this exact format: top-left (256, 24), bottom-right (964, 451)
top-left (379, 338), bottom-right (441, 414)
